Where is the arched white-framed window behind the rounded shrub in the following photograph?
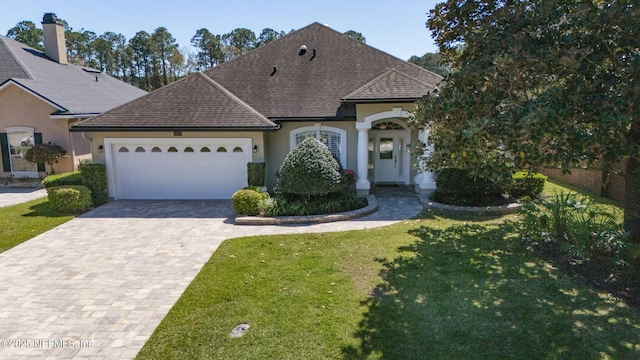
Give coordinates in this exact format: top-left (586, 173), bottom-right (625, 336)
top-left (289, 124), bottom-right (347, 167)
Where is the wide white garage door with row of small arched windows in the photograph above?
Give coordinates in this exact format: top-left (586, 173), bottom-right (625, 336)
top-left (105, 138), bottom-right (252, 199)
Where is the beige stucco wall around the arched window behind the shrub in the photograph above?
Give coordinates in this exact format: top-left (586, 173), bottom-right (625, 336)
top-left (265, 121), bottom-right (358, 189)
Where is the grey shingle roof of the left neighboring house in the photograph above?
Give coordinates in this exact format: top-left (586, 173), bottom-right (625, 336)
top-left (0, 36), bottom-right (146, 115)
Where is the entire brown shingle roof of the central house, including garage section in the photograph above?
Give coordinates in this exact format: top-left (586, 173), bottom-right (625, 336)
top-left (72, 23), bottom-right (442, 131)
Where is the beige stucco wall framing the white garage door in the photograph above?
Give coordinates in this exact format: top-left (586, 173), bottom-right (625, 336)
top-left (86, 131), bottom-right (265, 164)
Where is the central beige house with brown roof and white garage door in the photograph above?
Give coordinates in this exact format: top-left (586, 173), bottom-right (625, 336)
top-left (71, 23), bottom-right (441, 199)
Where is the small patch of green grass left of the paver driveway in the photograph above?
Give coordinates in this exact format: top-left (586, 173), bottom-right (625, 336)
top-left (0, 197), bottom-right (73, 253)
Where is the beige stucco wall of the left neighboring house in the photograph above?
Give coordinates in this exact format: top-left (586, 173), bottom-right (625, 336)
top-left (0, 84), bottom-right (89, 177)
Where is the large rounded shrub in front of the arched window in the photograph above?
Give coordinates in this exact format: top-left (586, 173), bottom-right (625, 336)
top-left (278, 137), bottom-right (343, 197)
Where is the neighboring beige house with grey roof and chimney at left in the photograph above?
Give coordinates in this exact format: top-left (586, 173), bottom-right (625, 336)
top-left (0, 14), bottom-right (146, 178)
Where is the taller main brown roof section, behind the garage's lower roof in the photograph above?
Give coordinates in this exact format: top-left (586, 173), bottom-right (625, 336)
top-left (206, 23), bottom-right (442, 118)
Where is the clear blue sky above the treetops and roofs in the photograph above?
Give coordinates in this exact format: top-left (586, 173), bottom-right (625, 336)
top-left (0, 0), bottom-right (439, 60)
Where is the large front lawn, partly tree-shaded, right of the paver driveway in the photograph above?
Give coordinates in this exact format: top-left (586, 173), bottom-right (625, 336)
top-left (138, 183), bottom-right (640, 359)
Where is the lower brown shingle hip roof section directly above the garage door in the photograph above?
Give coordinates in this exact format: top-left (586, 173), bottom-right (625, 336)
top-left (74, 73), bottom-right (277, 131)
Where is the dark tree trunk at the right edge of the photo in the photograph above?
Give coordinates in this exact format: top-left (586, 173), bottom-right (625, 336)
top-left (624, 158), bottom-right (640, 244)
